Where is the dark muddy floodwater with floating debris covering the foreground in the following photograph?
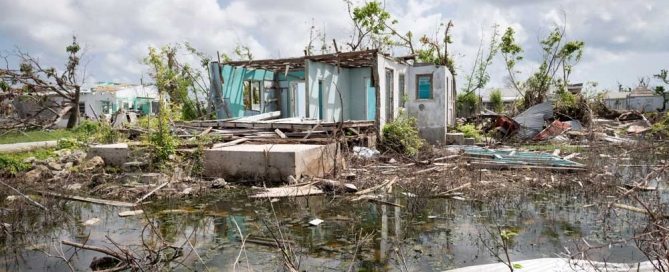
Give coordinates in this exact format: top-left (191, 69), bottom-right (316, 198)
top-left (0, 147), bottom-right (667, 271)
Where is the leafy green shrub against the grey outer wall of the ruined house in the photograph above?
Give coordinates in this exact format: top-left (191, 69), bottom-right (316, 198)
top-left (383, 111), bottom-right (424, 156)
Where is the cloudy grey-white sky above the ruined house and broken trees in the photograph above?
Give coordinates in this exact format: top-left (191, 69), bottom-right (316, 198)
top-left (0, 0), bottom-right (669, 89)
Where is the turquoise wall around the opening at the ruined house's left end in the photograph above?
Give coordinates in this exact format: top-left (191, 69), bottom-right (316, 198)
top-left (217, 65), bottom-right (274, 119)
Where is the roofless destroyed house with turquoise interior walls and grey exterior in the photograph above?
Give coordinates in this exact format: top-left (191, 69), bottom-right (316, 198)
top-left (209, 50), bottom-right (455, 143)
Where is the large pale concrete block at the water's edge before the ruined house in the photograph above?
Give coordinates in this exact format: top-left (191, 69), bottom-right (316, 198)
top-left (204, 144), bottom-right (338, 181)
